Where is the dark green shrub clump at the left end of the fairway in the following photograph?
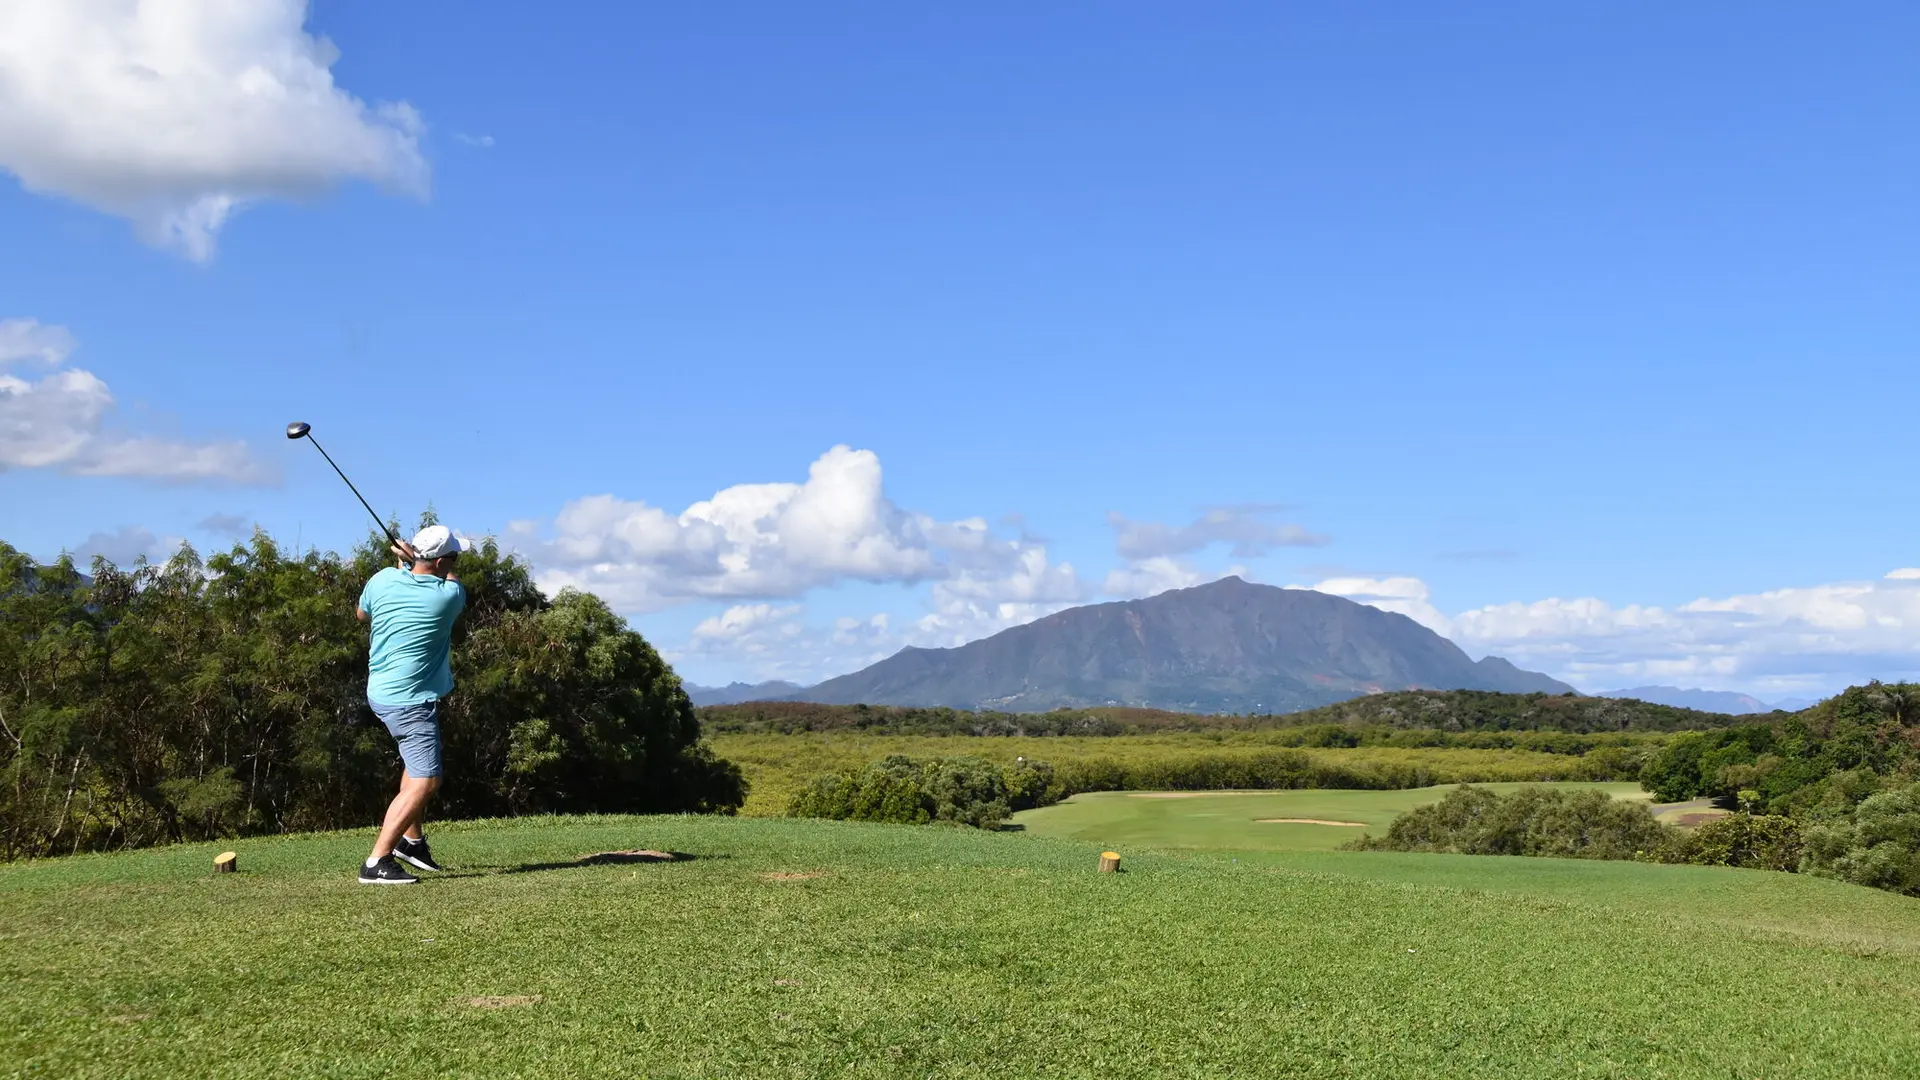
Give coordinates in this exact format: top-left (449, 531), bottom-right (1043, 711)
top-left (787, 755), bottom-right (1013, 828)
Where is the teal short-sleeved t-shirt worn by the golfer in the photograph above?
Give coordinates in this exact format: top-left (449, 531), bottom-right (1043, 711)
top-left (361, 567), bottom-right (467, 705)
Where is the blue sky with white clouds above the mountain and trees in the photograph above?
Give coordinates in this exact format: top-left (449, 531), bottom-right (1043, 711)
top-left (0, 0), bottom-right (1920, 698)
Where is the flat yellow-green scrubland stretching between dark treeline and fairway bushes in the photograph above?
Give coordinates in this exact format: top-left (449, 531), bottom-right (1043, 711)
top-left (707, 730), bottom-right (1620, 817)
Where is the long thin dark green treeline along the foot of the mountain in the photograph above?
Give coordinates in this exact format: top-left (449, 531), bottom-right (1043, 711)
top-left (699, 690), bottom-right (1740, 737)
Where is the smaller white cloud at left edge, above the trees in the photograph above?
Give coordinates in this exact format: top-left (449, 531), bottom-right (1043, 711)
top-left (0, 319), bottom-right (273, 484)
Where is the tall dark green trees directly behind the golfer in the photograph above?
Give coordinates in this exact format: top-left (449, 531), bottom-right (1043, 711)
top-left (0, 534), bottom-right (745, 859)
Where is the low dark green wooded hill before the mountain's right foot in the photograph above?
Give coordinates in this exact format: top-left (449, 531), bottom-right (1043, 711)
top-left (1286, 690), bottom-right (1741, 734)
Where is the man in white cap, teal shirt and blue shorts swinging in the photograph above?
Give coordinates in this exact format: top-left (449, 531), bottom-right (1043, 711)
top-left (357, 525), bottom-right (472, 886)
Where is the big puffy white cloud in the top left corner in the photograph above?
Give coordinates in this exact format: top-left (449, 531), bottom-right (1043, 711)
top-left (0, 0), bottom-right (428, 259)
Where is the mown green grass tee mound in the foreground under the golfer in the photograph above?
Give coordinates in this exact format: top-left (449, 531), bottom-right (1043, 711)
top-left (0, 819), bottom-right (1920, 1078)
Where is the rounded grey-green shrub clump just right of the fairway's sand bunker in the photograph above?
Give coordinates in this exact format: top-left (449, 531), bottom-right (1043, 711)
top-left (1350, 784), bottom-right (1670, 859)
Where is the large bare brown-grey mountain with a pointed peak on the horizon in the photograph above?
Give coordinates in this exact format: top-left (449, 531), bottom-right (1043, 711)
top-left (793, 577), bottom-right (1572, 713)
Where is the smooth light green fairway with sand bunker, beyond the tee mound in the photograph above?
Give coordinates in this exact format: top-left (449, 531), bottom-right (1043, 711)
top-left (1014, 784), bottom-right (1647, 851)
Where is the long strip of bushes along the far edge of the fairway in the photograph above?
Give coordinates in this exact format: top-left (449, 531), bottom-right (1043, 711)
top-left (787, 746), bottom-right (1653, 828)
